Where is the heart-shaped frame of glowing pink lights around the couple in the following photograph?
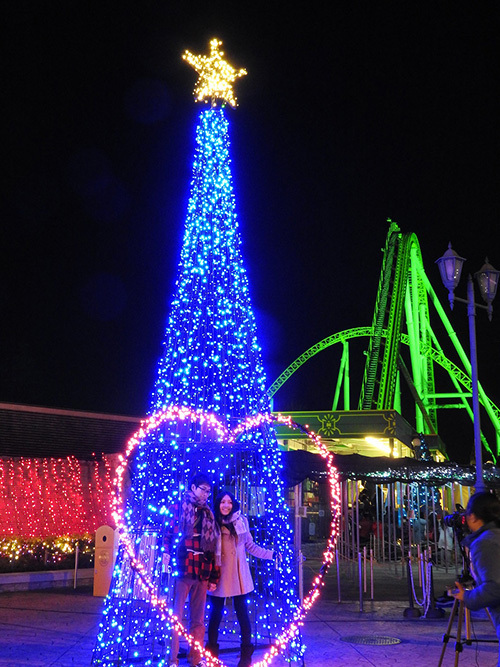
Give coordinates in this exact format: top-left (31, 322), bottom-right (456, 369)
top-left (112, 405), bottom-right (340, 667)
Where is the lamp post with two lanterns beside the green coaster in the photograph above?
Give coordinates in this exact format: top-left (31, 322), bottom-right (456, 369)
top-left (436, 243), bottom-right (500, 492)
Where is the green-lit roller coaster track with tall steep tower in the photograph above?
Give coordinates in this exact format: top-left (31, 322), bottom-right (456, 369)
top-left (268, 221), bottom-right (500, 460)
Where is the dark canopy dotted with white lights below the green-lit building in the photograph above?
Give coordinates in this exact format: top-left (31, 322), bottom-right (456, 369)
top-left (282, 450), bottom-right (500, 488)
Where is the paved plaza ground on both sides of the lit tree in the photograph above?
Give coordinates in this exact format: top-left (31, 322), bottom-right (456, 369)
top-left (0, 577), bottom-right (498, 667)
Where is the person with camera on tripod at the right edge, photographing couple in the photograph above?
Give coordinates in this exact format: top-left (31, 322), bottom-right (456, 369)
top-left (451, 492), bottom-right (500, 666)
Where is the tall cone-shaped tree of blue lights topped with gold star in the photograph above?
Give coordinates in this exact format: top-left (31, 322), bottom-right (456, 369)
top-left (94, 40), bottom-right (301, 665)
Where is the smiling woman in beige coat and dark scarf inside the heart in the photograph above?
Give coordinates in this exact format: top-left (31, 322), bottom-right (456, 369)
top-left (207, 491), bottom-right (275, 667)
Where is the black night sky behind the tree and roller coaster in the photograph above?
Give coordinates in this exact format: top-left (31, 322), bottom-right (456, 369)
top-left (0, 0), bottom-right (500, 458)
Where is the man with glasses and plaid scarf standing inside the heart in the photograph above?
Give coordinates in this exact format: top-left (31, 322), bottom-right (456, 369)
top-left (170, 473), bottom-right (220, 667)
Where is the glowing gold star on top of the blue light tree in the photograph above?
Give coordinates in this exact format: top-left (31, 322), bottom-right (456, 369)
top-left (182, 38), bottom-right (247, 107)
